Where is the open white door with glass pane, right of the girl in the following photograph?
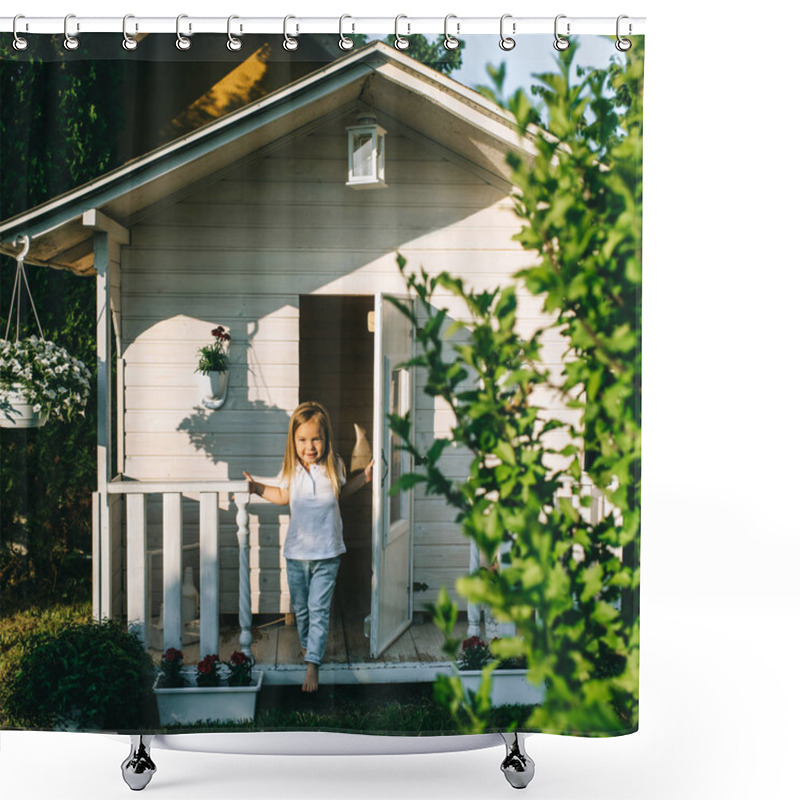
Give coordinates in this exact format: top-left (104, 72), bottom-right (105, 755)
top-left (369, 294), bottom-right (414, 658)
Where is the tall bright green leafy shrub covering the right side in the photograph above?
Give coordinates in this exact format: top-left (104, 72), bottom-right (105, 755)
top-left (391, 44), bottom-right (643, 735)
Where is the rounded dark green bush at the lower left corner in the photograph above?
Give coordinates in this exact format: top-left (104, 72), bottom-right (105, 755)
top-left (5, 620), bottom-right (153, 730)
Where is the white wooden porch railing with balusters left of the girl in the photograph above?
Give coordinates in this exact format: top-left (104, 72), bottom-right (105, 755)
top-left (108, 480), bottom-right (253, 656)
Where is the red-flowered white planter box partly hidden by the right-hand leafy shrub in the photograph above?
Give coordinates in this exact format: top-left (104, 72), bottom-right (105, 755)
top-left (456, 636), bottom-right (544, 706)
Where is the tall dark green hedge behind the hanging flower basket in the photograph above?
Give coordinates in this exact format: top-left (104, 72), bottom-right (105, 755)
top-left (0, 36), bottom-right (124, 604)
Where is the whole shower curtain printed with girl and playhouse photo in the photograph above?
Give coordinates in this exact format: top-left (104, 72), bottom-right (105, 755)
top-left (0, 25), bottom-right (644, 736)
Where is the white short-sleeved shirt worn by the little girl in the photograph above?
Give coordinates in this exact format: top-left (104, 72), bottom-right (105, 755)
top-left (278, 458), bottom-right (346, 561)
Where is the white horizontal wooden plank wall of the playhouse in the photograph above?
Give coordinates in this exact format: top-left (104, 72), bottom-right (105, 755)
top-left (122, 111), bottom-right (563, 613)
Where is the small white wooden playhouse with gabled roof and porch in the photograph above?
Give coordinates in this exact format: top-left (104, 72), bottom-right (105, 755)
top-left (0, 42), bottom-right (588, 680)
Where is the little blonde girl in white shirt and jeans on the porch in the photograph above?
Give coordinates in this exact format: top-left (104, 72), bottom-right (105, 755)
top-left (244, 402), bottom-right (372, 692)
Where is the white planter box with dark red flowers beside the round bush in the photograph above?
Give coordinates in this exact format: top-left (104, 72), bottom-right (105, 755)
top-left (154, 649), bottom-right (263, 725)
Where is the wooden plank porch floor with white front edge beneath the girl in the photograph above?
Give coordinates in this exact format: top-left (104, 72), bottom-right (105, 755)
top-left (150, 604), bottom-right (467, 684)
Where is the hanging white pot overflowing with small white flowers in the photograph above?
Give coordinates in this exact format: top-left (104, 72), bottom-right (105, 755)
top-left (0, 336), bottom-right (91, 428)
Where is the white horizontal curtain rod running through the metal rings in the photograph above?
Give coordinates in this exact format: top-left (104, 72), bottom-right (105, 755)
top-left (0, 14), bottom-right (645, 36)
